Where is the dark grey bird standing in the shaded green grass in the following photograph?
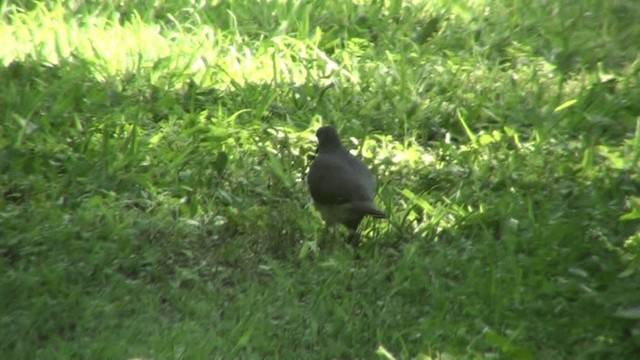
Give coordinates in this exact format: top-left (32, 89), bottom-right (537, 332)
top-left (307, 126), bottom-right (387, 245)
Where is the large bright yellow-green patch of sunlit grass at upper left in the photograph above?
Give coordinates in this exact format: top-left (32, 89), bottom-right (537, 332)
top-left (0, 6), bottom-right (349, 86)
